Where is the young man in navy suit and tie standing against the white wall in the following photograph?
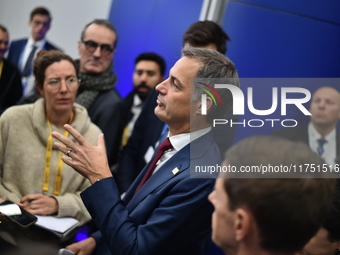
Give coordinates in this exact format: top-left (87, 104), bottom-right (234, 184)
top-left (7, 7), bottom-right (57, 97)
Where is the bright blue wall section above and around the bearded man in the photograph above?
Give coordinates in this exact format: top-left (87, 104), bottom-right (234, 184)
top-left (109, 0), bottom-right (203, 96)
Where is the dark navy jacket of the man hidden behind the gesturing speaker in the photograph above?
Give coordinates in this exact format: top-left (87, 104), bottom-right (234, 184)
top-left (116, 89), bottom-right (238, 192)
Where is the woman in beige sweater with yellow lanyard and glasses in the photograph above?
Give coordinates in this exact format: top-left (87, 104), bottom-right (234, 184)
top-left (0, 50), bottom-right (101, 249)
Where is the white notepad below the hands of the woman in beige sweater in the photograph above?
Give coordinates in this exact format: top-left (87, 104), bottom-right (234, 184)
top-left (35, 215), bottom-right (79, 238)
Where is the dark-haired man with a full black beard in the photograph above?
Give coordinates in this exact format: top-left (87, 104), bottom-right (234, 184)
top-left (122, 52), bottom-right (165, 146)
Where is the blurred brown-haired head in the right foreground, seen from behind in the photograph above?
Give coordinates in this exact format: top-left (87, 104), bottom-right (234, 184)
top-left (209, 136), bottom-right (335, 255)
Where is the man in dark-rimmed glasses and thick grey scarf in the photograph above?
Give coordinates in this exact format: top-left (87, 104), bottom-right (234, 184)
top-left (75, 19), bottom-right (125, 166)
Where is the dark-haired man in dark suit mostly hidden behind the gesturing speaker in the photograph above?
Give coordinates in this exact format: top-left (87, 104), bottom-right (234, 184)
top-left (116, 20), bottom-right (236, 192)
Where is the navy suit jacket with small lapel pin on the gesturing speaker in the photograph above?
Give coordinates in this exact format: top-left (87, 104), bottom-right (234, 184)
top-left (81, 132), bottom-right (221, 255)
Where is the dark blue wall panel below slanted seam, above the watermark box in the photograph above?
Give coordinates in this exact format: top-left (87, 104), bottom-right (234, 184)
top-left (223, 2), bottom-right (340, 77)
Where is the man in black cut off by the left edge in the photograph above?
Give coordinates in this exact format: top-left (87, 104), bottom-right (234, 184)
top-left (0, 25), bottom-right (22, 115)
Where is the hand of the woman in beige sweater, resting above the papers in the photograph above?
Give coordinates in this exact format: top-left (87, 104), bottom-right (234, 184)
top-left (18, 194), bottom-right (59, 216)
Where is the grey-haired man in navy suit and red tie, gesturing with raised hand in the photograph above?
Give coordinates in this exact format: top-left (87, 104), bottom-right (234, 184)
top-left (53, 47), bottom-right (238, 255)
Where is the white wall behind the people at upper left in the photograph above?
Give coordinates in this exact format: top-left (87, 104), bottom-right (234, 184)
top-left (0, 0), bottom-right (111, 58)
